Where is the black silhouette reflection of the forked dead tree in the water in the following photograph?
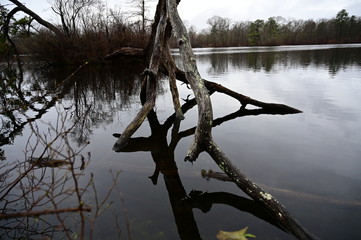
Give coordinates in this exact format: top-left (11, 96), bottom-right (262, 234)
top-left (114, 96), bottom-right (292, 239)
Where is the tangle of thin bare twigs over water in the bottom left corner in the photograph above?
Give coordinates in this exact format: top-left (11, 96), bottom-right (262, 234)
top-left (0, 104), bottom-right (119, 239)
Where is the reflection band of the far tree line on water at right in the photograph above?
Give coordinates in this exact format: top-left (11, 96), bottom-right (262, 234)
top-left (196, 45), bottom-right (361, 75)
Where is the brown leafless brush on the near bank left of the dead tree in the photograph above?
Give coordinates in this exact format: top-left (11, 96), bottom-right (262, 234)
top-left (0, 0), bottom-right (149, 64)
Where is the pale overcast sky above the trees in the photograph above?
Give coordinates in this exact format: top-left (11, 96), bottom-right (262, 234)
top-left (0, 0), bottom-right (361, 30)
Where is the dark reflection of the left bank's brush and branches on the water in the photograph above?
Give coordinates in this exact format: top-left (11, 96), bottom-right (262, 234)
top-left (0, 64), bottom-right (141, 146)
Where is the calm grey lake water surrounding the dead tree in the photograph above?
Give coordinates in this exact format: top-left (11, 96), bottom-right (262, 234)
top-left (0, 44), bottom-right (361, 239)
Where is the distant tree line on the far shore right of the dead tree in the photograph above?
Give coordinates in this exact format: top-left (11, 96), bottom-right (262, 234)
top-left (189, 9), bottom-right (361, 47)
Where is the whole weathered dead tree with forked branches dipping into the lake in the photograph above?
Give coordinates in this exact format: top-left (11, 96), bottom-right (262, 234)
top-left (113, 0), bottom-right (314, 239)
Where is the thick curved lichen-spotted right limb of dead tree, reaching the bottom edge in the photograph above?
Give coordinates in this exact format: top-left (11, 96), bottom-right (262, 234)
top-left (167, 0), bottom-right (313, 239)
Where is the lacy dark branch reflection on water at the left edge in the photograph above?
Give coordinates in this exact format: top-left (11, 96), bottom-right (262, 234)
top-left (0, 65), bottom-right (80, 149)
